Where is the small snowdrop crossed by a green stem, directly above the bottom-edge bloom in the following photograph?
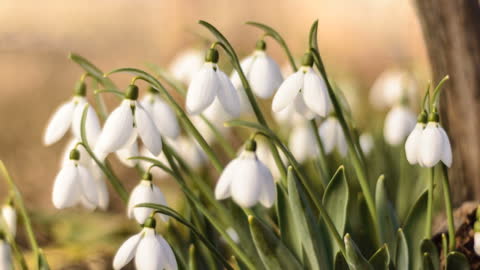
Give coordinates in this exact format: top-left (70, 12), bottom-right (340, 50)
top-left (127, 172), bottom-right (168, 224)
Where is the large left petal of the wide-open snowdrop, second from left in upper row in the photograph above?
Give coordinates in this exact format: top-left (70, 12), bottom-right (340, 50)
top-left (95, 100), bottom-right (134, 159)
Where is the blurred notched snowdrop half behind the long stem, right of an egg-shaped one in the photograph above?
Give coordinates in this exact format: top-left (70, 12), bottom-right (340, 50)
top-left (318, 116), bottom-right (348, 157)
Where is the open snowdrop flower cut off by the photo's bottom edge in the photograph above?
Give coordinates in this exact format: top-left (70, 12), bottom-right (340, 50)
top-left (113, 218), bottom-right (178, 270)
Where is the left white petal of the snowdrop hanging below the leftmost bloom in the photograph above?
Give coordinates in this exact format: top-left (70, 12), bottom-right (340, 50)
top-left (52, 163), bottom-right (81, 209)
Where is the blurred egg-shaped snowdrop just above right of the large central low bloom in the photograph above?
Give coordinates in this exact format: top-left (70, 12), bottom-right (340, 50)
top-left (288, 120), bottom-right (318, 163)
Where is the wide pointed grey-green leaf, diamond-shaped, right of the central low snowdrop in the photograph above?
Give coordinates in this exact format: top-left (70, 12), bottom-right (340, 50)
top-left (323, 166), bottom-right (349, 240)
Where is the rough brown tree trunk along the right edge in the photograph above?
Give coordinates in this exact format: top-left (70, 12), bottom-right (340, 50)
top-left (416, 0), bottom-right (480, 202)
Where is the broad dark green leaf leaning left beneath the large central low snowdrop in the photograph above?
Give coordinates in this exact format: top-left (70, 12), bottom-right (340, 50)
top-left (248, 216), bottom-right (303, 270)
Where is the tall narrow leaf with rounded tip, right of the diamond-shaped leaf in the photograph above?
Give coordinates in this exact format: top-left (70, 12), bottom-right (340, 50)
top-left (375, 175), bottom-right (398, 254)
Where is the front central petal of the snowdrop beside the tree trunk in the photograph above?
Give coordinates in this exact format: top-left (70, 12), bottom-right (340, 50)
top-left (420, 122), bottom-right (444, 167)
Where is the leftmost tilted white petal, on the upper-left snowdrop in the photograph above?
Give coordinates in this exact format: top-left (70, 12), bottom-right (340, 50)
top-left (43, 101), bottom-right (75, 145)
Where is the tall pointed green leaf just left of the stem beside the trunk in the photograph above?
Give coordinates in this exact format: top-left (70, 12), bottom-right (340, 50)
top-left (404, 191), bottom-right (427, 269)
